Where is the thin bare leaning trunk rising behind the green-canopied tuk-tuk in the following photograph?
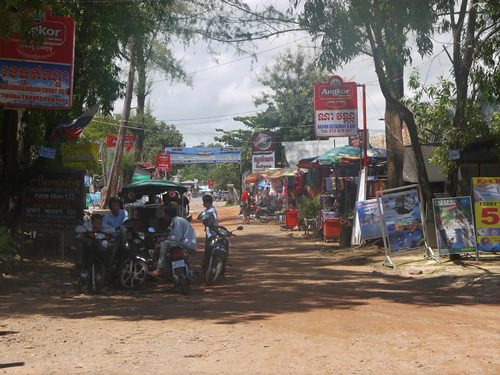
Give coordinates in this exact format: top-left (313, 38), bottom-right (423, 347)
top-left (101, 37), bottom-right (135, 208)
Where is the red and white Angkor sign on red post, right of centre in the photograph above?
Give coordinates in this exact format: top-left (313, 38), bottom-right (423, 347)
top-left (314, 76), bottom-right (358, 137)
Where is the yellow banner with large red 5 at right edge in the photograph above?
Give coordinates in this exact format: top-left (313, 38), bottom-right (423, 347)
top-left (472, 177), bottom-right (500, 251)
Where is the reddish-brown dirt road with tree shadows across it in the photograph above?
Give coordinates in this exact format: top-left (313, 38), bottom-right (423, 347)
top-left (0, 207), bottom-right (500, 374)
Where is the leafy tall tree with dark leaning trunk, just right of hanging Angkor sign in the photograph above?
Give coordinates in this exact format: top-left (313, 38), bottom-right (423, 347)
top-left (296, 0), bottom-right (446, 206)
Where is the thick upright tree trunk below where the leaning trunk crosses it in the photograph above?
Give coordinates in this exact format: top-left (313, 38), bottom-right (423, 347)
top-left (384, 101), bottom-right (404, 188)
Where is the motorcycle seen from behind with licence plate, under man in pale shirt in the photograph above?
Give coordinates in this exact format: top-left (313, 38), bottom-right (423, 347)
top-left (148, 228), bottom-right (196, 296)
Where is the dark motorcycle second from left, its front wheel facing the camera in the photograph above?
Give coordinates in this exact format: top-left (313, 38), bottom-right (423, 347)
top-left (117, 219), bottom-right (152, 289)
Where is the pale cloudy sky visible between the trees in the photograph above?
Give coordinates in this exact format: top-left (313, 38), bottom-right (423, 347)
top-left (115, 0), bottom-right (451, 147)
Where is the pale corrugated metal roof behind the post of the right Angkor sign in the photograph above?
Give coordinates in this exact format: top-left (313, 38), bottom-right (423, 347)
top-left (281, 137), bottom-right (349, 168)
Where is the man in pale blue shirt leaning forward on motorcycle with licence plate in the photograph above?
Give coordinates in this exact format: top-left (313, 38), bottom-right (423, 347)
top-left (149, 206), bottom-right (196, 279)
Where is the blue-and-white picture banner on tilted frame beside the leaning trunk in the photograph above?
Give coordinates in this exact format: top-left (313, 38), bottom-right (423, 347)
top-left (377, 190), bottom-right (425, 255)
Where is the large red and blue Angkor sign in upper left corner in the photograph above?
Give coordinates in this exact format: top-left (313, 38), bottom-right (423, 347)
top-left (0, 11), bottom-right (75, 109)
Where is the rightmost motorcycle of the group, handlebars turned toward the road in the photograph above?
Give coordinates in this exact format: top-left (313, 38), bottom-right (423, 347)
top-left (198, 211), bottom-right (243, 285)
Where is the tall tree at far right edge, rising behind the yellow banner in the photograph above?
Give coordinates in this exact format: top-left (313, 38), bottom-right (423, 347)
top-left (441, 0), bottom-right (500, 196)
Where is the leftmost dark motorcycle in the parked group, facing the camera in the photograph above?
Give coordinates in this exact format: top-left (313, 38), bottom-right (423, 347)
top-left (78, 232), bottom-right (112, 294)
